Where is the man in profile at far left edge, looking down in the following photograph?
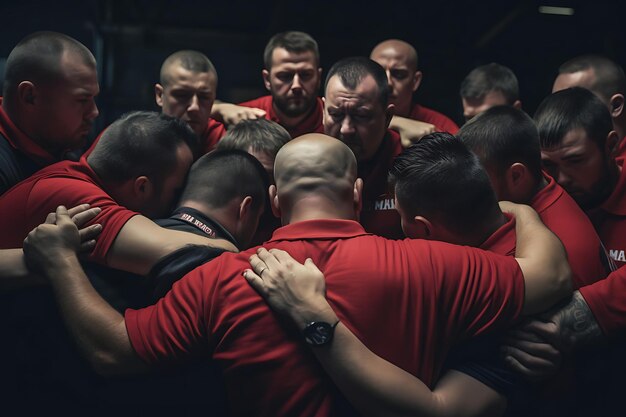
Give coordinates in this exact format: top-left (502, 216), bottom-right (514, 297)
top-left (0, 32), bottom-right (99, 194)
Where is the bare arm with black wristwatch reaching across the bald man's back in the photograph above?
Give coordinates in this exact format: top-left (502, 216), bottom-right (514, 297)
top-left (300, 307), bottom-right (506, 417)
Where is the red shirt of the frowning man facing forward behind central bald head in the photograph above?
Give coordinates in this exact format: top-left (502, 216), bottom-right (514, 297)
top-left (358, 130), bottom-right (404, 239)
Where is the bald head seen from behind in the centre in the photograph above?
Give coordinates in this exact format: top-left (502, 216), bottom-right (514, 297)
top-left (270, 133), bottom-right (363, 224)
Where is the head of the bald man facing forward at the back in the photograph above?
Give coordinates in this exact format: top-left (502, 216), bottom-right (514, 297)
top-left (370, 39), bottom-right (422, 117)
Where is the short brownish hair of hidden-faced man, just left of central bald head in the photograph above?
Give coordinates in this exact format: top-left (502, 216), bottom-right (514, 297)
top-left (217, 118), bottom-right (291, 158)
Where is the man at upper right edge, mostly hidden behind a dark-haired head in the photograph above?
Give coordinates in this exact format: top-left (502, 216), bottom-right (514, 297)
top-left (552, 55), bottom-right (626, 156)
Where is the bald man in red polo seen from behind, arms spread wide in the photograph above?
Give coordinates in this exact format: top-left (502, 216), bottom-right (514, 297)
top-left (25, 134), bottom-right (569, 416)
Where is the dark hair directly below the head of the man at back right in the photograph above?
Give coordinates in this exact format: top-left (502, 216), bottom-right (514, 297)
top-left (456, 106), bottom-right (541, 179)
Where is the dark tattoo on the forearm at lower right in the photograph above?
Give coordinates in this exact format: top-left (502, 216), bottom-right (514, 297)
top-left (556, 291), bottom-right (603, 349)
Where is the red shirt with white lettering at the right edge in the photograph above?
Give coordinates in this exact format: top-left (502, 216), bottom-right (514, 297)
top-left (587, 157), bottom-right (626, 268)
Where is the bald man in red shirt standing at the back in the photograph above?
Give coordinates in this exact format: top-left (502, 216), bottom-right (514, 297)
top-left (370, 39), bottom-right (459, 146)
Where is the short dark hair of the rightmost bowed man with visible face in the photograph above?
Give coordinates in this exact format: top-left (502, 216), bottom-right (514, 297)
top-left (535, 87), bottom-right (613, 149)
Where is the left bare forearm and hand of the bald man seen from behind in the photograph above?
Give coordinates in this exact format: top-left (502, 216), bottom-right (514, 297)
top-left (24, 207), bottom-right (147, 375)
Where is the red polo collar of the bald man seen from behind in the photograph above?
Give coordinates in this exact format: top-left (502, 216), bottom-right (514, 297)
top-left (268, 219), bottom-right (371, 242)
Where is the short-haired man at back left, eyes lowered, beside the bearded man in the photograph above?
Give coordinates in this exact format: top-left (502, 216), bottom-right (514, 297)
top-left (154, 50), bottom-right (226, 154)
